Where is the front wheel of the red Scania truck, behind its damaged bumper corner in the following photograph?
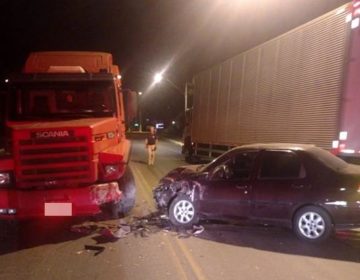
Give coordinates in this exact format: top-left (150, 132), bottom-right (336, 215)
top-left (117, 167), bottom-right (136, 214)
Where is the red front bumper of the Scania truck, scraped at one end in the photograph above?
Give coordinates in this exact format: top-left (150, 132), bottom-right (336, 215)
top-left (0, 182), bottom-right (122, 219)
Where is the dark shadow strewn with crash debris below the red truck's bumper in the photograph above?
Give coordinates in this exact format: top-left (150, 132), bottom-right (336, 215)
top-left (0, 212), bottom-right (168, 256)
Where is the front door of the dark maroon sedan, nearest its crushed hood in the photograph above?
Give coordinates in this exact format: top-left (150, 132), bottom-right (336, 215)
top-left (200, 151), bottom-right (257, 217)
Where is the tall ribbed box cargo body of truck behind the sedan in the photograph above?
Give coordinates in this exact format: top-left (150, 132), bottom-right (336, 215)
top-left (185, 1), bottom-right (360, 162)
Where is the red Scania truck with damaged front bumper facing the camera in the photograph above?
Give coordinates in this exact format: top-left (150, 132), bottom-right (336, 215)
top-left (0, 52), bottom-right (135, 219)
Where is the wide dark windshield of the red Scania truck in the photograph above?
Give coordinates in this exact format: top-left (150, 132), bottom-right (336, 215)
top-left (10, 81), bottom-right (116, 120)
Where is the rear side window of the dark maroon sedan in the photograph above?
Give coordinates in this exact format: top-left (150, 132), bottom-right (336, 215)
top-left (259, 151), bottom-right (305, 179)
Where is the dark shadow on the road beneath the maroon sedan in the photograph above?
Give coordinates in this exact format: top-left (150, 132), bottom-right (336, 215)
top-left (199, 221), bottom-right (360, 262)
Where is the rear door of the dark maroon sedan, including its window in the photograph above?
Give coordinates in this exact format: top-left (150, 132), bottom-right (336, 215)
top-left (251, 150), bottom-right (309, 220)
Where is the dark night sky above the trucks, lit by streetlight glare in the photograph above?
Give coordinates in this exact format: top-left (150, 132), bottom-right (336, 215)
top-left (0, 0), bottom-right (348, 122)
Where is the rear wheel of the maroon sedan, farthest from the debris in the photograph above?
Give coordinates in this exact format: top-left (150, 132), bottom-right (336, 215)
top-left (293, 206), bottom-right (333, 243)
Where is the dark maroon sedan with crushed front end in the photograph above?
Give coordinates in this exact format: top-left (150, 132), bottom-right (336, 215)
top-left (154, 144), bottom-right (360, 242)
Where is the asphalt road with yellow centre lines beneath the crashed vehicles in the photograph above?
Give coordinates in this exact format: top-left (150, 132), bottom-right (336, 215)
top-left (0, 141), bottom-right (360, 280)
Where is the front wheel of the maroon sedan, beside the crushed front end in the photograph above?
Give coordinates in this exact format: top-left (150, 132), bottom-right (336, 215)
top-left (168, 194), bottom-right (199, 228)
